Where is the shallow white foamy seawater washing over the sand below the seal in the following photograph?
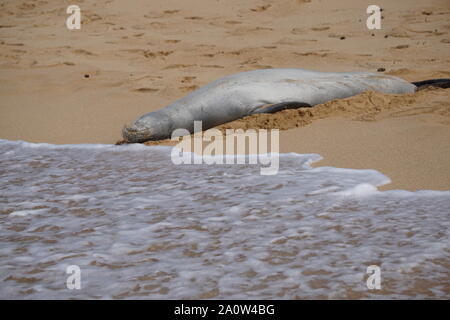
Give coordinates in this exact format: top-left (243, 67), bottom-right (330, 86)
top-left (0, 140), bottom-right (450, 299)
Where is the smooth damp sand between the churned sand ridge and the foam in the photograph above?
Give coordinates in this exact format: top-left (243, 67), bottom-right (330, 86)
top-left (280, 115), bottom-right (450, 190)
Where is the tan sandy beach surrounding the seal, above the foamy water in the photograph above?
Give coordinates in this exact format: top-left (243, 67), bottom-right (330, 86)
top-left (0, 0), bottom-right (450, 190)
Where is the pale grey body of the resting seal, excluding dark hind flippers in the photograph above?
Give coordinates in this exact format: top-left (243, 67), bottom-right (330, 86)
top-left (122, 69), bottom-right (416, 142)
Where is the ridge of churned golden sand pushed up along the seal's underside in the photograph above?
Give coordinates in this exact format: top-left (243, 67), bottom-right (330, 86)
top-left (137, 87), bottom-right (450, 145)
